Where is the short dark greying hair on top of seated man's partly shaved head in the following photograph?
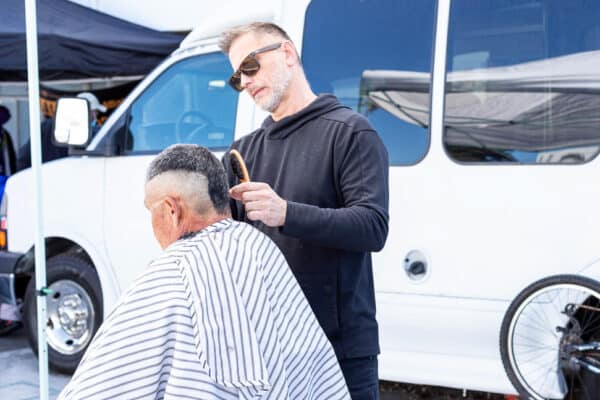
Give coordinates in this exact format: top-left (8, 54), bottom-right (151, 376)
top-left (146, 144), bottom-right (229, 214)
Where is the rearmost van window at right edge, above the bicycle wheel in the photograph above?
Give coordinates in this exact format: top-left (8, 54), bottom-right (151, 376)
top-left (444, 0), bottom-right (600, 164)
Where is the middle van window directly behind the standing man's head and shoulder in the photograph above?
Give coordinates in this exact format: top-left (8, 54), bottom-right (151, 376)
top-left (302, 0), bottom-right (435, 165)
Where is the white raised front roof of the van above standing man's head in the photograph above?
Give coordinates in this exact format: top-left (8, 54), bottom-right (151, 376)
top-left (177, 0), bottom-right (282, 51)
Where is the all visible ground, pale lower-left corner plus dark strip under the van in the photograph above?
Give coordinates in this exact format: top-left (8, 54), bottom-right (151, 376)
top-left (0, 328), bottom-right (504, 400)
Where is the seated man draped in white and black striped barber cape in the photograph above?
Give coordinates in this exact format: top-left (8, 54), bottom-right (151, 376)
top-left (59, 145), bottom-right (350, 400)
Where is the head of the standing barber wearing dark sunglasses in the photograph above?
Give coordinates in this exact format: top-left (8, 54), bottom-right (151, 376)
top-left (219, 22), bottom-right (306, 113)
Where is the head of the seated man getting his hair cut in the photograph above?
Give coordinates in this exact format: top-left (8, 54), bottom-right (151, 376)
top-left (144, 144), bottom-right (230, 249)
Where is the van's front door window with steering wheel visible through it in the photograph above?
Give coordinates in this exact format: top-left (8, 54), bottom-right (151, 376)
top-left (126, 53), bottom-right (238, 152)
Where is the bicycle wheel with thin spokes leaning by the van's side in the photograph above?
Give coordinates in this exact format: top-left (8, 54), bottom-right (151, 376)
top-left (500, 275), bottom-right (600, 400)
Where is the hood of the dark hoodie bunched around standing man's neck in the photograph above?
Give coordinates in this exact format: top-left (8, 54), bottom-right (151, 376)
top-left (261, 94), bottom-right (349, 139)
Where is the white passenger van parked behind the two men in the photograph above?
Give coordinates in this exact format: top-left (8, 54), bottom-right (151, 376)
top-left (0, 0), bottom-right (600, 400)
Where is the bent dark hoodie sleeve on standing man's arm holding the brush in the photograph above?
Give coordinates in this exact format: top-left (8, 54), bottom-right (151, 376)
top-left (281, 130), bottom-right (389, 251)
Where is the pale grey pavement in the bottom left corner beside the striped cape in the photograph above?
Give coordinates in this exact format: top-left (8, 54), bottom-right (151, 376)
top-left (0, 329), bottom-right (71, 400)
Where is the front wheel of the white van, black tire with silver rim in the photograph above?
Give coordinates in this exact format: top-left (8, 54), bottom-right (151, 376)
top-left (23, 252), bottom-right (103, 374)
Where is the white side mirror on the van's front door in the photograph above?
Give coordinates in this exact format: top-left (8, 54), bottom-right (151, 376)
top-left (52, 97), bottom-right (91, 147)
